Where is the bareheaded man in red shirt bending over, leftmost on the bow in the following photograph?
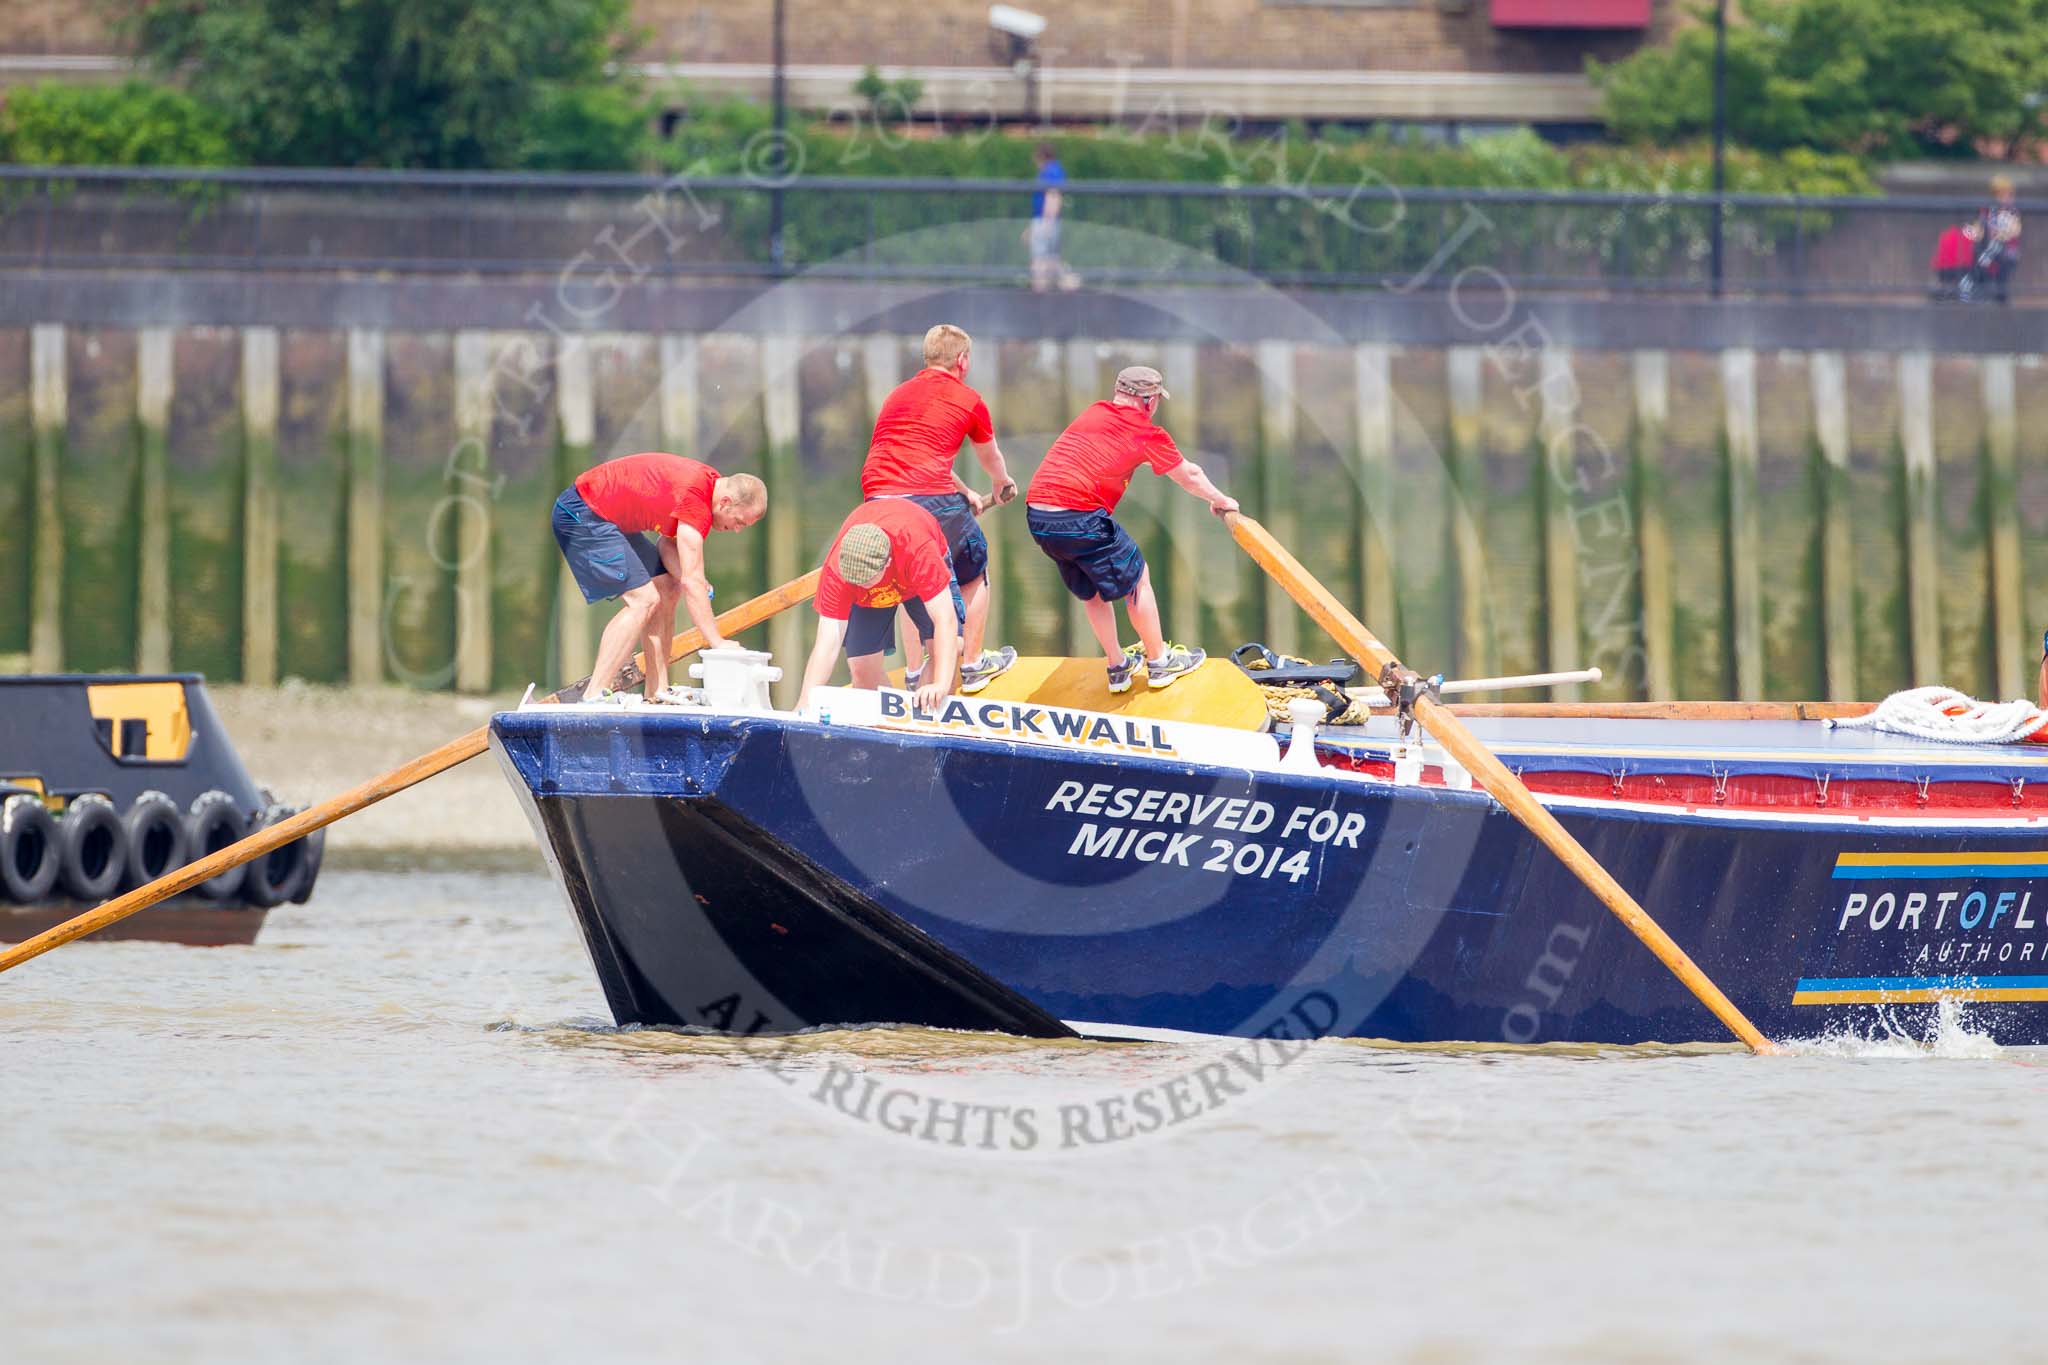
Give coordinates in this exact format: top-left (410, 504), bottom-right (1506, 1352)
top-left (553, 450), bottom-right (768, 702)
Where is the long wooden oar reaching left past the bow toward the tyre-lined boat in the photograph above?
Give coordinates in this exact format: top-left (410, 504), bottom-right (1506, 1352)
top-left (0, 569), bottom-right (817, 972)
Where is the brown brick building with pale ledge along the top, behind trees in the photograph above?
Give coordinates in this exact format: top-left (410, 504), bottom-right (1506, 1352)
top-left (0, 0), bottom-right (1681, 125)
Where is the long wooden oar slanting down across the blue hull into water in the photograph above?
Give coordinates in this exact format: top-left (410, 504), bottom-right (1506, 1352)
top-left (1223, 512), bottom-right (1778, 1052)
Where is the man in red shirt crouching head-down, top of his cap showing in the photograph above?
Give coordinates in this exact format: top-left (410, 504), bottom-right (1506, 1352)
top-left (797, 497), bottom-right (967, 710)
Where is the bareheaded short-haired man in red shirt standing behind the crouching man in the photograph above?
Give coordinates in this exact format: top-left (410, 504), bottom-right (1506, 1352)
top-left (860, 323), bottom-right (1018, 692)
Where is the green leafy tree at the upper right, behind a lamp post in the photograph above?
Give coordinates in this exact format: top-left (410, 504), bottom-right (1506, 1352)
top-left (1587, 0), bottom-right (2048, 156)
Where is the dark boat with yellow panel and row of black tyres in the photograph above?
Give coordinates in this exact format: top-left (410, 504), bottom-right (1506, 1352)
top-left (0, 673), bottom-right (324, 945)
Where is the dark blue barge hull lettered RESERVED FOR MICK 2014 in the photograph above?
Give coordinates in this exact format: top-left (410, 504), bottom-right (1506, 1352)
top-left (492, 708), bottom-right (2048, 1044)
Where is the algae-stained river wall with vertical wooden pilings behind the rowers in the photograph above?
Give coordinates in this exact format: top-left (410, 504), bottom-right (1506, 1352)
top-left (0, 325), bottom-right (2048, 698)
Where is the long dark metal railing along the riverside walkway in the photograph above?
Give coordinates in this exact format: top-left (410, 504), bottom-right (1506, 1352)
top-left (0, 166), bottom-right (2048, 303)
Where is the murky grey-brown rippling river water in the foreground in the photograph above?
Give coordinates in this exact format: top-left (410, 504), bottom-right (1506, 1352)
top-left (0, 870), bottom-right (2048, 1363)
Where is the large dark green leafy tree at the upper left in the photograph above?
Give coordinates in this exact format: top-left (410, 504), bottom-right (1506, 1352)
top-left (115, 0), bottom-right (647, 170)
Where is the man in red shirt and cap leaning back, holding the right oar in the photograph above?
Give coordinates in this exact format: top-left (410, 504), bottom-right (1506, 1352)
top-left (1024, 364), bottom-right (1237, 692)
